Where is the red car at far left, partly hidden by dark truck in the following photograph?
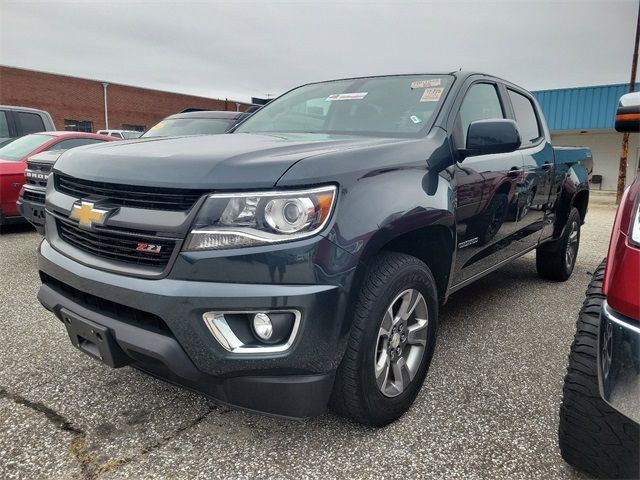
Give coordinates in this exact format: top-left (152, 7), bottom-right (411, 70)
top-left (0, 132), bottom-right (117, 226)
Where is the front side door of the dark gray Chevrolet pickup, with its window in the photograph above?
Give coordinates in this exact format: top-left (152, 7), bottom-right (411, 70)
top-left (451, 79), bottom-right (523, 286)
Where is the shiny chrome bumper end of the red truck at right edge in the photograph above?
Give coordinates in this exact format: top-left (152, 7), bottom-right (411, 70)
top-left (598, 301), bottom-right (640, 423)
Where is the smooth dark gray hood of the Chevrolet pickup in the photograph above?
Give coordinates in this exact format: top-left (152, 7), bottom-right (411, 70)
top-left (54, 133), bottom-right (399, 189)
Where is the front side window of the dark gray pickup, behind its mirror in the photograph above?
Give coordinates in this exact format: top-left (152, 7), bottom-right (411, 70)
top-left (454, 83), bottom-right (505, 148)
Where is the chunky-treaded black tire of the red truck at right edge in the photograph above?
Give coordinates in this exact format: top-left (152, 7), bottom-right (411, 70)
top-left (558, 262), bottom-right (640, 478)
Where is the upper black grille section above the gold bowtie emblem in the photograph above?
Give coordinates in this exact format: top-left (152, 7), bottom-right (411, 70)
top-left (54, 174), bottom-right (208, 211)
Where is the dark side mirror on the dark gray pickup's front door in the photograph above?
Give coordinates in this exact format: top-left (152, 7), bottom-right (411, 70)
top-left (460, 119), bottom-right (521, 157)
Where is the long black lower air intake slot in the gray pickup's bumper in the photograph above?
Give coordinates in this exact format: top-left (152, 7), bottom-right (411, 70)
top-left (40, 272), bottom-right (173, 336)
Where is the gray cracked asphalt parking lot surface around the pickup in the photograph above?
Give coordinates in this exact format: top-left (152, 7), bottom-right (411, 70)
top-left (0, 205), bottom-right (615, 479)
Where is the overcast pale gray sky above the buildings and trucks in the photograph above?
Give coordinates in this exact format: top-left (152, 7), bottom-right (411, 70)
top-left (0, 0), bottom-right (638, 101)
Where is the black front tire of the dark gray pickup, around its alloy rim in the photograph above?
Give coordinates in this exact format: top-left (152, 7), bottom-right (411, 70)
top-left (330, 252), bottom-right (438, 427)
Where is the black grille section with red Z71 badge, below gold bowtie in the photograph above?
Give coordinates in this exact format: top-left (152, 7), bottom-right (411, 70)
top-left (56, 218), bottom-right (177, 268)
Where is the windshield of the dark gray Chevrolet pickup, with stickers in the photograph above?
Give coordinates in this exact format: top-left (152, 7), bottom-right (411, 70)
top-left (236, 75), bottom-right (452, 137)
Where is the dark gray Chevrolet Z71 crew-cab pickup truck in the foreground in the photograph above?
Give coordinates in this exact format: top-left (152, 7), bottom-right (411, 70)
top-left (38, 72), bottom-right (592, 426)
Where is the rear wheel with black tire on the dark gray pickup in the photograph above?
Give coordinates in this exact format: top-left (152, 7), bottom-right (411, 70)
top-left (536, 207), bottom-right (582, 282)
